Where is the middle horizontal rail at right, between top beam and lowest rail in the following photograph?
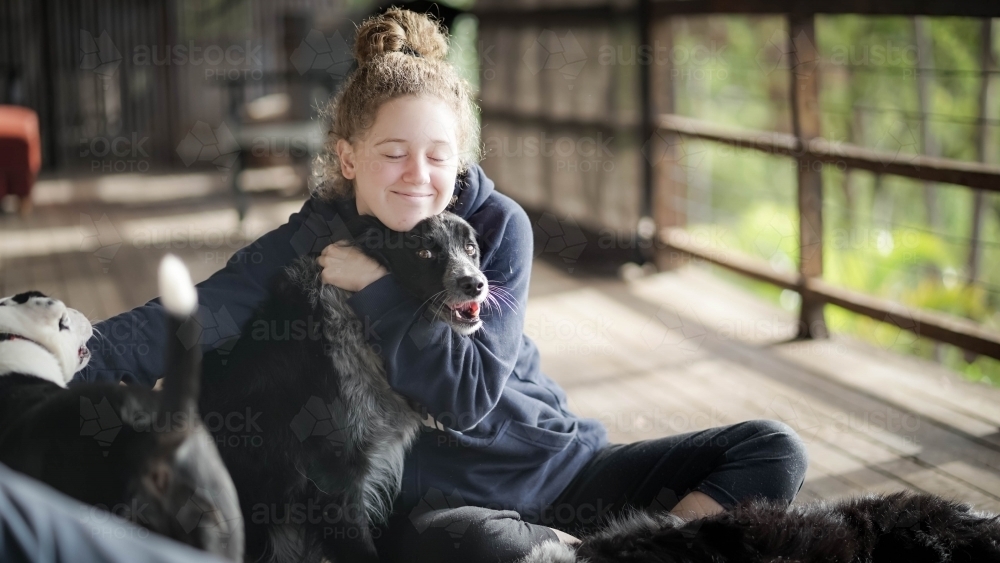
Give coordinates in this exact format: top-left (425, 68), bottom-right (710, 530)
top-left (658, 115), bottom-right (1000, 192)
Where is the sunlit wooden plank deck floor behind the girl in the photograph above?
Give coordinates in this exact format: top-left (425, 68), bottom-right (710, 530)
top-left (0, 185), bottom-right (1000, 512)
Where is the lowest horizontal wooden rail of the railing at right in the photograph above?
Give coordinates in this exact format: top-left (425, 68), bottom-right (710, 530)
top-left (660, 228), bottom-right (1000, 359)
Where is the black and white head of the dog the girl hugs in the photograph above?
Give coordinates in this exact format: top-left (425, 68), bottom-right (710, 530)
top-left (353, 212), bottom-right (490, 335)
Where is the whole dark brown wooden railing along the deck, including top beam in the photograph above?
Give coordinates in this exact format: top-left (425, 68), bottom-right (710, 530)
top-left (474, 0), bottom-right (1000, 359)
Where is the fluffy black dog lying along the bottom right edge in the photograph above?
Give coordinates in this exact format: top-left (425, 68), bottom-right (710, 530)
top-left (521, 491), bottom-right (1000, 563)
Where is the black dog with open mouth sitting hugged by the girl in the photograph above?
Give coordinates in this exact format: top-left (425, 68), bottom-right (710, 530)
top-left (201, 213), bottom-right (489, 563)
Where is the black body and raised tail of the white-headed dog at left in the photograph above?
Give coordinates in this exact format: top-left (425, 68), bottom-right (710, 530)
top-left (0, 268), bottom-right (243, 561)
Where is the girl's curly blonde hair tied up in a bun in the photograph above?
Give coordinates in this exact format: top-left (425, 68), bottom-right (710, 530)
top-left (313, 7), bottom-right (482, 199)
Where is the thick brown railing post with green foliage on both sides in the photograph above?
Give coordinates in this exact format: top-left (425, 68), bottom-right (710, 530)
top-left (788, 13), bottom-right (829, 338)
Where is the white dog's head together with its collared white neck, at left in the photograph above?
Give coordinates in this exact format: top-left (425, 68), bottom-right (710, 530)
top-left (0, 291), bottom-right (94, 386)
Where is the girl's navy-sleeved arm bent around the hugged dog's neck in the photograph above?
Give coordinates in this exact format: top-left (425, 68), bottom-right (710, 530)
top-left (348, 193), bottom-right (532, 431)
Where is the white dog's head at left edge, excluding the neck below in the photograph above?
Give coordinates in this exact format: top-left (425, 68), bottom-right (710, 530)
top-left (0, 291), bottom-right (94, 385)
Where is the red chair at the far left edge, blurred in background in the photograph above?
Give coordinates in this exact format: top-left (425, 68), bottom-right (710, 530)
top-left (0, 105), bottom-right (42, 215)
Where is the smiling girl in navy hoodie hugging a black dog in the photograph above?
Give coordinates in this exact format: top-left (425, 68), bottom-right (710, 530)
top-left (82, 9), bottom-right (807, 562)
